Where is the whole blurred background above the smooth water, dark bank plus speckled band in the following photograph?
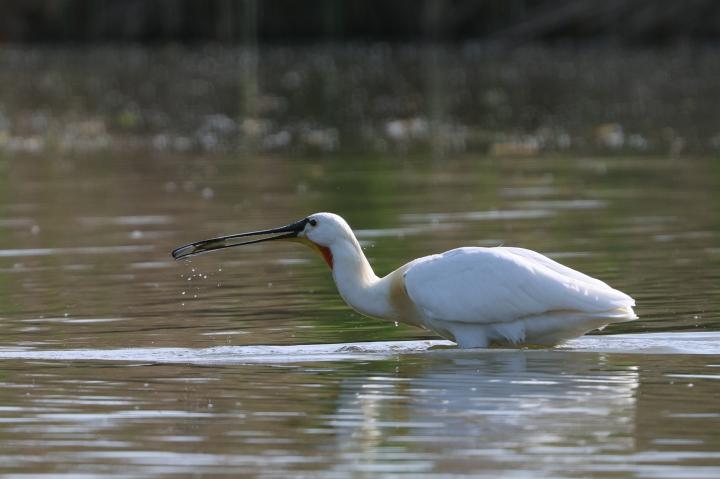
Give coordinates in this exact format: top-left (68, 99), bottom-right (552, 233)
top-left (0, 0), bottom-right (720, 156)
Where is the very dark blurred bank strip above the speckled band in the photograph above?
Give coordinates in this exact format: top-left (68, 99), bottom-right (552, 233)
top-left (0, 0), bottom-right (720, 45)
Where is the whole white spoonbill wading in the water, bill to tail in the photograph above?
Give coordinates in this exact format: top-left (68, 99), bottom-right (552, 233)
top-left (172, 213), bottom-right (637, 348)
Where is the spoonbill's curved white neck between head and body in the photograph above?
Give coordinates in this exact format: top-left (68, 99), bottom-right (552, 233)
top-left (330, 237), bottom-right (395, 319)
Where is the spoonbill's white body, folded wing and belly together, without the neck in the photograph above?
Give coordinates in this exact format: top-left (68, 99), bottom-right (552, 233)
top-left (404, 247), bottom-right (635, 347)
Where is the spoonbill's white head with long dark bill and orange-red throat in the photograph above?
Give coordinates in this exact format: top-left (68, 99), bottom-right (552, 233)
top-left (172, 213), bottom-right (354, 268)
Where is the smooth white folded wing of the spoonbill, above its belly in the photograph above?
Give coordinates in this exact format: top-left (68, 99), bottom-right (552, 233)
top-left (404, 247), bottom-right (634, 323)
